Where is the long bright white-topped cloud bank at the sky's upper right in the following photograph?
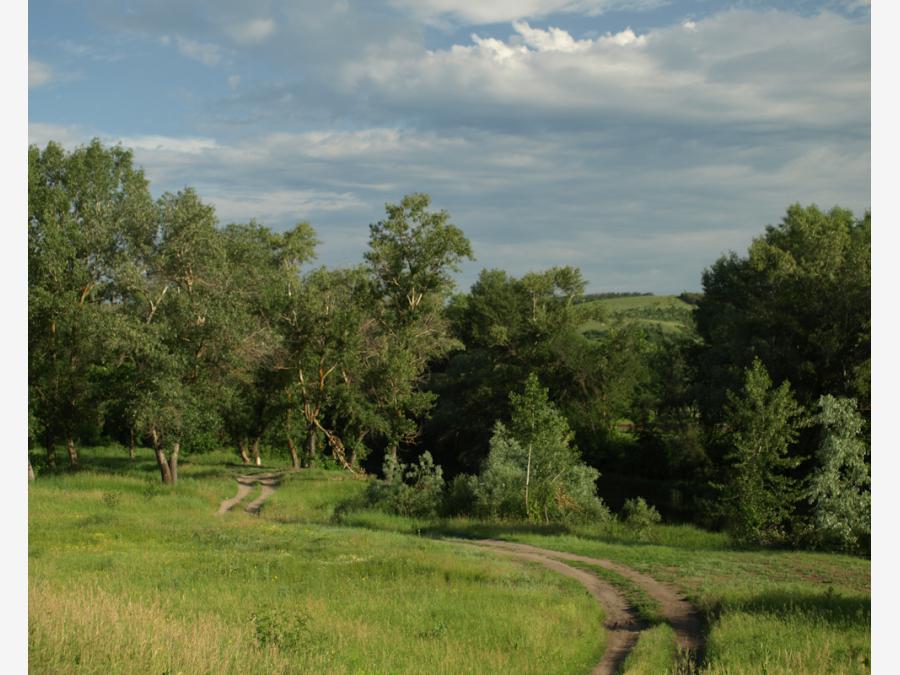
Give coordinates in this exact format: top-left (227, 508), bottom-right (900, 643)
top-left (343, 11), bottom-right (870, 129)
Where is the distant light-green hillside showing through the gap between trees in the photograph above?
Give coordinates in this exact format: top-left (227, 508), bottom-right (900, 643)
top-left (581, 295), bottom-right (694, 335)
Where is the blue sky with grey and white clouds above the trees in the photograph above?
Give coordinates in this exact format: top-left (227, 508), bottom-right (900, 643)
top-left (28, 0), bottom-right (871, 293)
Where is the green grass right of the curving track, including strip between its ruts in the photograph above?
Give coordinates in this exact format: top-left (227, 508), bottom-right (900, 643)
top-left (328, 511), bottom-right (871, 673)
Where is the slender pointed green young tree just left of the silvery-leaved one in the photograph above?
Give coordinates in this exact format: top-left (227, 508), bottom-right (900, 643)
top-left (722, 359), bottom-right (805, 545)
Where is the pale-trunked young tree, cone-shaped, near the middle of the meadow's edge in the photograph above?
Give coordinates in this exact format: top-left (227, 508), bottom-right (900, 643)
top-left (475, 373), bottom-right (607, 522)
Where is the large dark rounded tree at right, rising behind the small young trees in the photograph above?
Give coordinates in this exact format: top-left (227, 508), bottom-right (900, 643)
top-left (694, 204), bottom-right (871, 421)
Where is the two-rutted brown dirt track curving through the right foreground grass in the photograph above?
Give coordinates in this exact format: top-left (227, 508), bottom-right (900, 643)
top-left (475, 539), bottom-right (706, 673)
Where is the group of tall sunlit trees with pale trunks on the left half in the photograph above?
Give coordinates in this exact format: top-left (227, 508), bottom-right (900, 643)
top-left (28, 141), bottom-right (471, 483)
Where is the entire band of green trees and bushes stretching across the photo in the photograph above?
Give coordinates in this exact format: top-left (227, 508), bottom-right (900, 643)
top-left (28, 141), bottom-right (871, 549)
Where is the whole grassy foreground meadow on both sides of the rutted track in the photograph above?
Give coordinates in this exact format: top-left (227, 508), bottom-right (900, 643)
top-left (28, 448), bottom-right (871, 673)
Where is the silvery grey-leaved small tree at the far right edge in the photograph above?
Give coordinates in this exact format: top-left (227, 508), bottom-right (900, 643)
top-left (806, 395), bottom-right (872, 549)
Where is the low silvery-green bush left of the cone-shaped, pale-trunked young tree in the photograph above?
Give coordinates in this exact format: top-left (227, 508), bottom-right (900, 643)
top-left (366, 452), bottom-right (444, 518)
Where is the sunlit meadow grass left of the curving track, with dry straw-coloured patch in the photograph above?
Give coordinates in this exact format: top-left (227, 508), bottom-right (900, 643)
top-left (28, 450), bottom-right (603, 673)
